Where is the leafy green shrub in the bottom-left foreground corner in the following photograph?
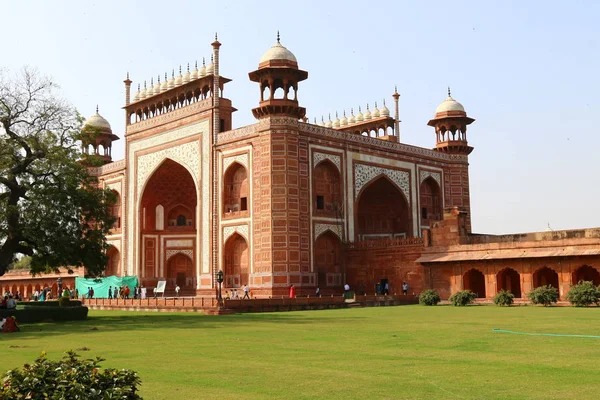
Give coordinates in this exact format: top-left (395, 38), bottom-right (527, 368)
top-left (0, 351), bottom-right (141, 400)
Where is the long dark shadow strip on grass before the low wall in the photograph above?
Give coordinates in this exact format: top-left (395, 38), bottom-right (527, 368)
top-left (15, 310), bottom-right (365, 338)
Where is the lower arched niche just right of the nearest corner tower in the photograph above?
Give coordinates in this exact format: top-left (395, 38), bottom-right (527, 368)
top-left (314, 231), bottom-right (342, 288)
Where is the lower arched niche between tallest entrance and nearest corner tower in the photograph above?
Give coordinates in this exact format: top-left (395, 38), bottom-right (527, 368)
top-left (223, 232), bottom-right (250, 288)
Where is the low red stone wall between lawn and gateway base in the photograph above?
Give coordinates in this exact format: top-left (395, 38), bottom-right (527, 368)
top-left (83, 295), bottom-right (418, 314)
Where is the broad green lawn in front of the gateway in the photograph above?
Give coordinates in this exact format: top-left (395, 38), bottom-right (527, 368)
top-left (0, 306), bottom-right (600, 400)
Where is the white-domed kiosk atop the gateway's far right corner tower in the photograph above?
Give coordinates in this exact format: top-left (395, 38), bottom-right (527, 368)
top-left (427, 88), bottom-right (475, 155)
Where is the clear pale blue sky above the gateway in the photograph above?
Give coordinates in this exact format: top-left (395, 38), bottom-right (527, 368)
top-left (0, 0), bottom-right (600, 233)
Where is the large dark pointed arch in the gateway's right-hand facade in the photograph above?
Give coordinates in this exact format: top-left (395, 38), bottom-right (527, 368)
top-left (357, 176), bottom-right (412, 240)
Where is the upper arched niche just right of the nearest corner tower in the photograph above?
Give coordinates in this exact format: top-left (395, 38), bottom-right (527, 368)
top-left (312, 160), bottom-right (344, 220)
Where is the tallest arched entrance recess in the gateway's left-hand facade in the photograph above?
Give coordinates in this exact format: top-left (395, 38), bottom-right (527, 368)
top-left (137, 159), bottom-right (198, 289)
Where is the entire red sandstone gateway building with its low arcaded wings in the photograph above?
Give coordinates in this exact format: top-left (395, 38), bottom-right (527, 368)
top-left (0, 36), bottom-right (600, 304)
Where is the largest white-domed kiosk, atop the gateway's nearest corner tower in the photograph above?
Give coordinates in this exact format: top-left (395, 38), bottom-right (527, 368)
top-left (248, 31), bottom-right (308, 119)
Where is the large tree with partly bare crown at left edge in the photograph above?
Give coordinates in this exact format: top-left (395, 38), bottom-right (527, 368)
top-left (0, 69), bottom-right (115, 276)
